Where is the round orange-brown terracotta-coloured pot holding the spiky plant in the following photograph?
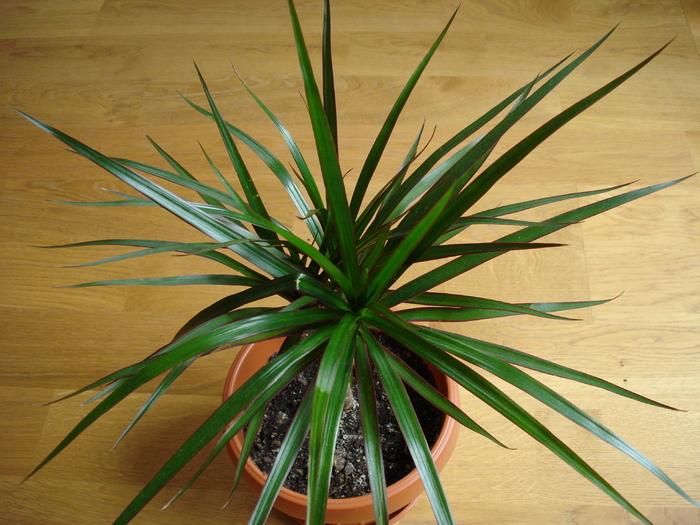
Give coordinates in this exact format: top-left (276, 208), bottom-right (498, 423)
top-left (224, 339), bottom-right (459, 525)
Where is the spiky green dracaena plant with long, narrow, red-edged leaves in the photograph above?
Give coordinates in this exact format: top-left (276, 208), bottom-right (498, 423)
top-left (16, 0), bottom-right (697, 524)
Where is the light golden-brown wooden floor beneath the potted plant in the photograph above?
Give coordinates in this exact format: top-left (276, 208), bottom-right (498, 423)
top-left (0, 0), bottom-right (700, 525)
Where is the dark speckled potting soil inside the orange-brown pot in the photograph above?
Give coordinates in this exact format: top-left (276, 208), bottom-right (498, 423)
top-left (246, 334), bottom-right (444, 498)
